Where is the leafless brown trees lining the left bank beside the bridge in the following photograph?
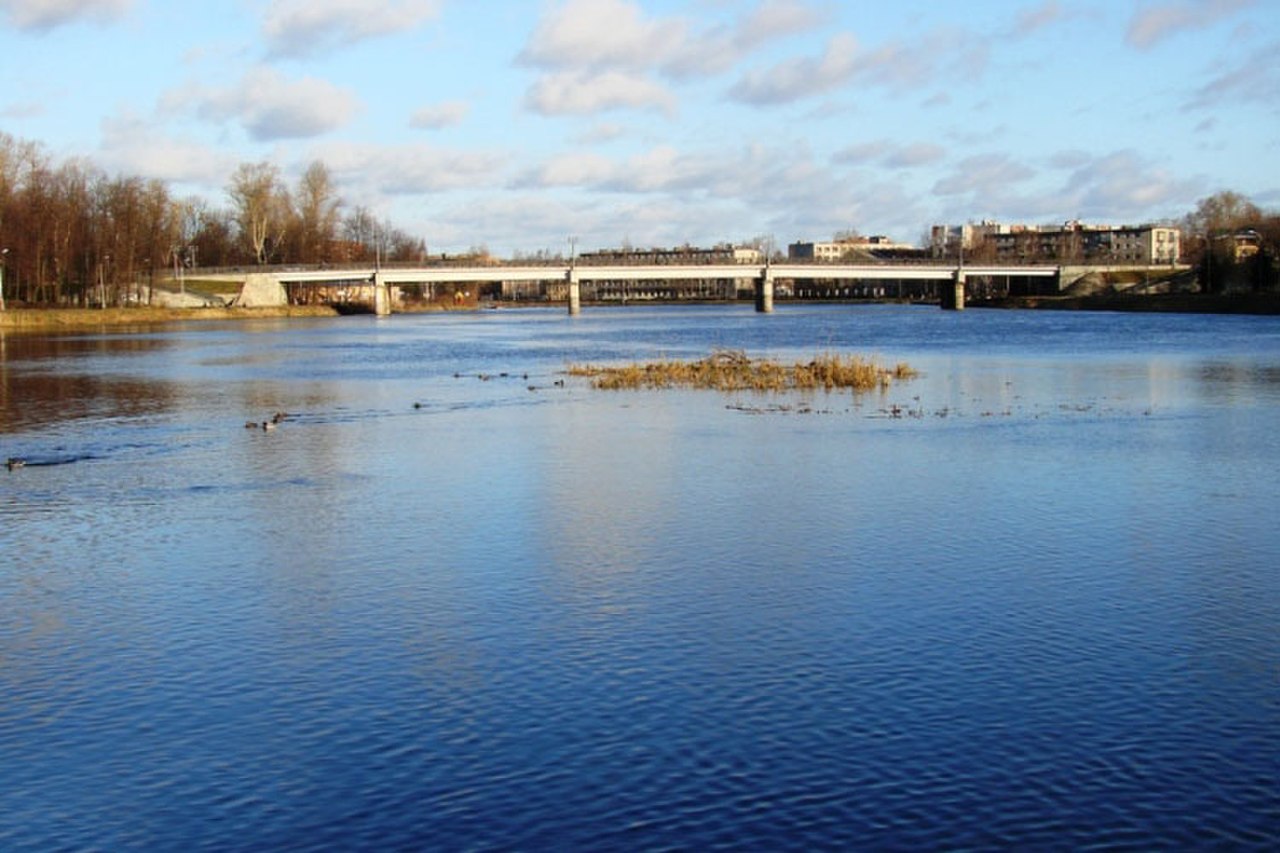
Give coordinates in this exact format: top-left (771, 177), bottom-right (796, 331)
top-left (0, 132), bottom-right (426, 306)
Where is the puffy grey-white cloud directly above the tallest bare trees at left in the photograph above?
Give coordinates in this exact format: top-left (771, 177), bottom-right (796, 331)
top-left (180, 67), bottom-right (358, 142)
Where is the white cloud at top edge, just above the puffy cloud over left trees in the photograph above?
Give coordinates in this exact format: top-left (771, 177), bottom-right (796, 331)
top-left (262, 0), bottom-right (440, 56)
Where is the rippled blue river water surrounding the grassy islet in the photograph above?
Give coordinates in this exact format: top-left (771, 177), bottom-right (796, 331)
top-left (0, 305), bottom-right (1280, 850)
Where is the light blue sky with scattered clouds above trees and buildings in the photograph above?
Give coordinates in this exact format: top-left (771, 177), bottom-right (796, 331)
top-left (0, 0), bottom-right (1280, 257)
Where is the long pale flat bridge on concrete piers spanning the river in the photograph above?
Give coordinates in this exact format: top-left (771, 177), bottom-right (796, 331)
top-left (197, 263), bottom-right (1062, 315)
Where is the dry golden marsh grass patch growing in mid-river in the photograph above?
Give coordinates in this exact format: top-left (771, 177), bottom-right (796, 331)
top-left (568, 350), bottom-right (916, 392)
